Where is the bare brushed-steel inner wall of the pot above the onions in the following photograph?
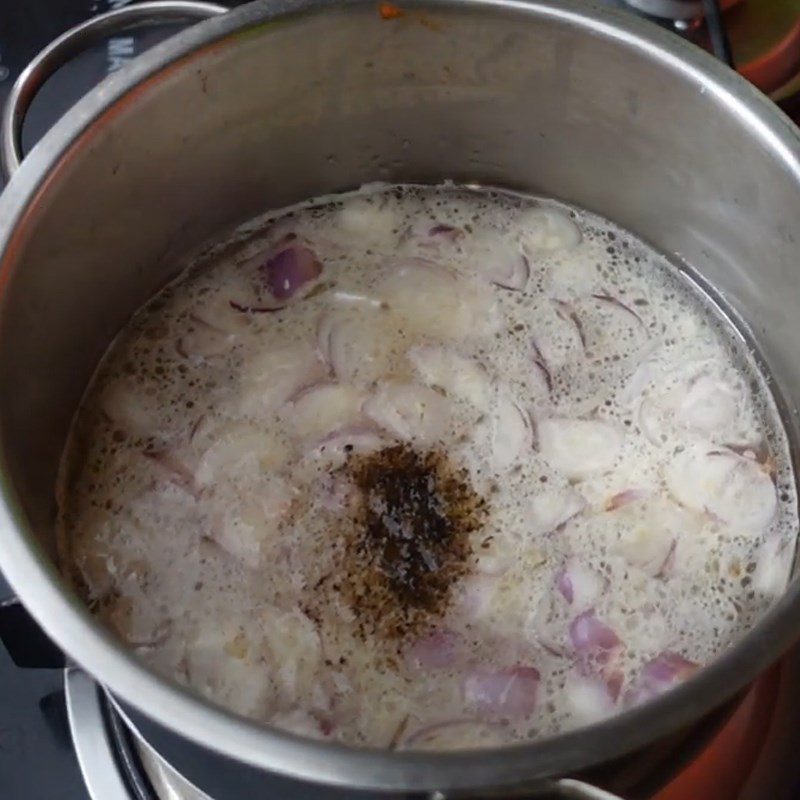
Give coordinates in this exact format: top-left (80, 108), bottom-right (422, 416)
top-left (0, 4), bottom-right (800, 576)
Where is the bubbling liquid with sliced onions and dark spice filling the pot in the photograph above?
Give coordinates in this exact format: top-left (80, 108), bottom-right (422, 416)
top-left (60, 186), bottom-right (797, 748)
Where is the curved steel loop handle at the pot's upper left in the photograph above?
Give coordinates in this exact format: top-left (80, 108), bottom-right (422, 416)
top-left (0, 0), bottom-right (228, 180)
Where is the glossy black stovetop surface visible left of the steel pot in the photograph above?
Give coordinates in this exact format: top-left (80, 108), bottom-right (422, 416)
top-left (0, 0), bottom-right (800, 800)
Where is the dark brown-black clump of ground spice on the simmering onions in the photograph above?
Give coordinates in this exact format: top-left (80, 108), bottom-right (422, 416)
top-left (341, 445), bottom-right (488, 639)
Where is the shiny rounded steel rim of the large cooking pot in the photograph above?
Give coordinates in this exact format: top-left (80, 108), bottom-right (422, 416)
top-left (0, 0), bottom-right (800, 791)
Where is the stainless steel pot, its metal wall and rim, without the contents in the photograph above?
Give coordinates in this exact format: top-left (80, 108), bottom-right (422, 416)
top-left (0, 0), bottom-right (800, 796)
